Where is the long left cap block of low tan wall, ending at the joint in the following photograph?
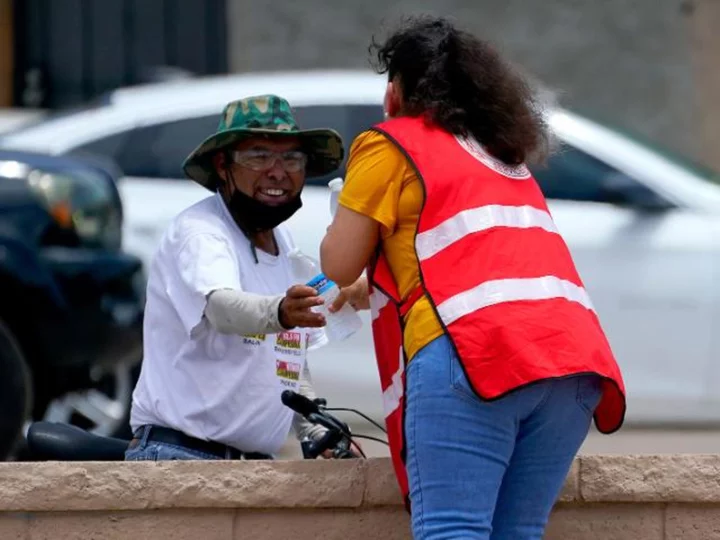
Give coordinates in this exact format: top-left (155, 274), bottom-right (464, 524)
top-left (0, 460), bottom-right (374, 512)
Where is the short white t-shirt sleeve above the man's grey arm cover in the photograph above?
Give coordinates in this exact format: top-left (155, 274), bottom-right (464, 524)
top-left (166, 233), bottom-right (242, 336)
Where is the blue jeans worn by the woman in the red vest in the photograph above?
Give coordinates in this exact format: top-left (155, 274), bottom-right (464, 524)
top-left (405, 336), bottom-right (601, 540)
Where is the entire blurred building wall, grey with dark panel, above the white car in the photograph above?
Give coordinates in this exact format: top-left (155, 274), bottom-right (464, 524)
top-left (0, 0), bottom-right (720, 170)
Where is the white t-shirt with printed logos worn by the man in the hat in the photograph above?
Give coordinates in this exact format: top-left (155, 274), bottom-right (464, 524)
top-left (130, 194), bottom-right (326, 454)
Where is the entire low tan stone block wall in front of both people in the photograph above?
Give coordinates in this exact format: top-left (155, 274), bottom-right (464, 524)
top-left (0, 454), bottom-right (720, 540)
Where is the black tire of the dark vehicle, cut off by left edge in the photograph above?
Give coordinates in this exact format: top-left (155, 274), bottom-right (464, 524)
top-left (0, 320), bottom-right (33, 461)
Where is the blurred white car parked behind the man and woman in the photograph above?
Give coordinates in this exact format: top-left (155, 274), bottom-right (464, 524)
top-left (0, 71), bottom-right (720, 423)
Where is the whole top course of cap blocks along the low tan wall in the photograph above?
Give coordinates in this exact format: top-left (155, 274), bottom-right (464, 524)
top-left (0, 454), bottom-right (720, 512)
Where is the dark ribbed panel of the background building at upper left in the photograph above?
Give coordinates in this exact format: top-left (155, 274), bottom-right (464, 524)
top-left (0, 0), bottom-right (229, 109)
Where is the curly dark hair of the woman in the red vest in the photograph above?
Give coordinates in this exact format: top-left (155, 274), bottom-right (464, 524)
top-left (369, 15), bottom-right (549, 165)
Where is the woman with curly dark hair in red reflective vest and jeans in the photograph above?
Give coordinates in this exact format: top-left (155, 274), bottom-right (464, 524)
top-left (321, 17), bottom-right (625, 540)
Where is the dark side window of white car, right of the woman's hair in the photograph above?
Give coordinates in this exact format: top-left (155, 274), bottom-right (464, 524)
top-left (530, 145), bottom-right (668, 206)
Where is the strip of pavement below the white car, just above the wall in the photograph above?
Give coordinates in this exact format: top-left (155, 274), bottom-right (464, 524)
top-left (279, 424), bottom-right (720, 459)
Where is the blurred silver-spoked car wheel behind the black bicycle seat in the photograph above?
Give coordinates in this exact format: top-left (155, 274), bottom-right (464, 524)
top-left (43, 356), bottom-right (140, 439)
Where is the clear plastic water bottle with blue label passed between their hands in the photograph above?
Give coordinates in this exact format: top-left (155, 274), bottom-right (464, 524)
top-left (288, 248), bottom-right (362, 341)
